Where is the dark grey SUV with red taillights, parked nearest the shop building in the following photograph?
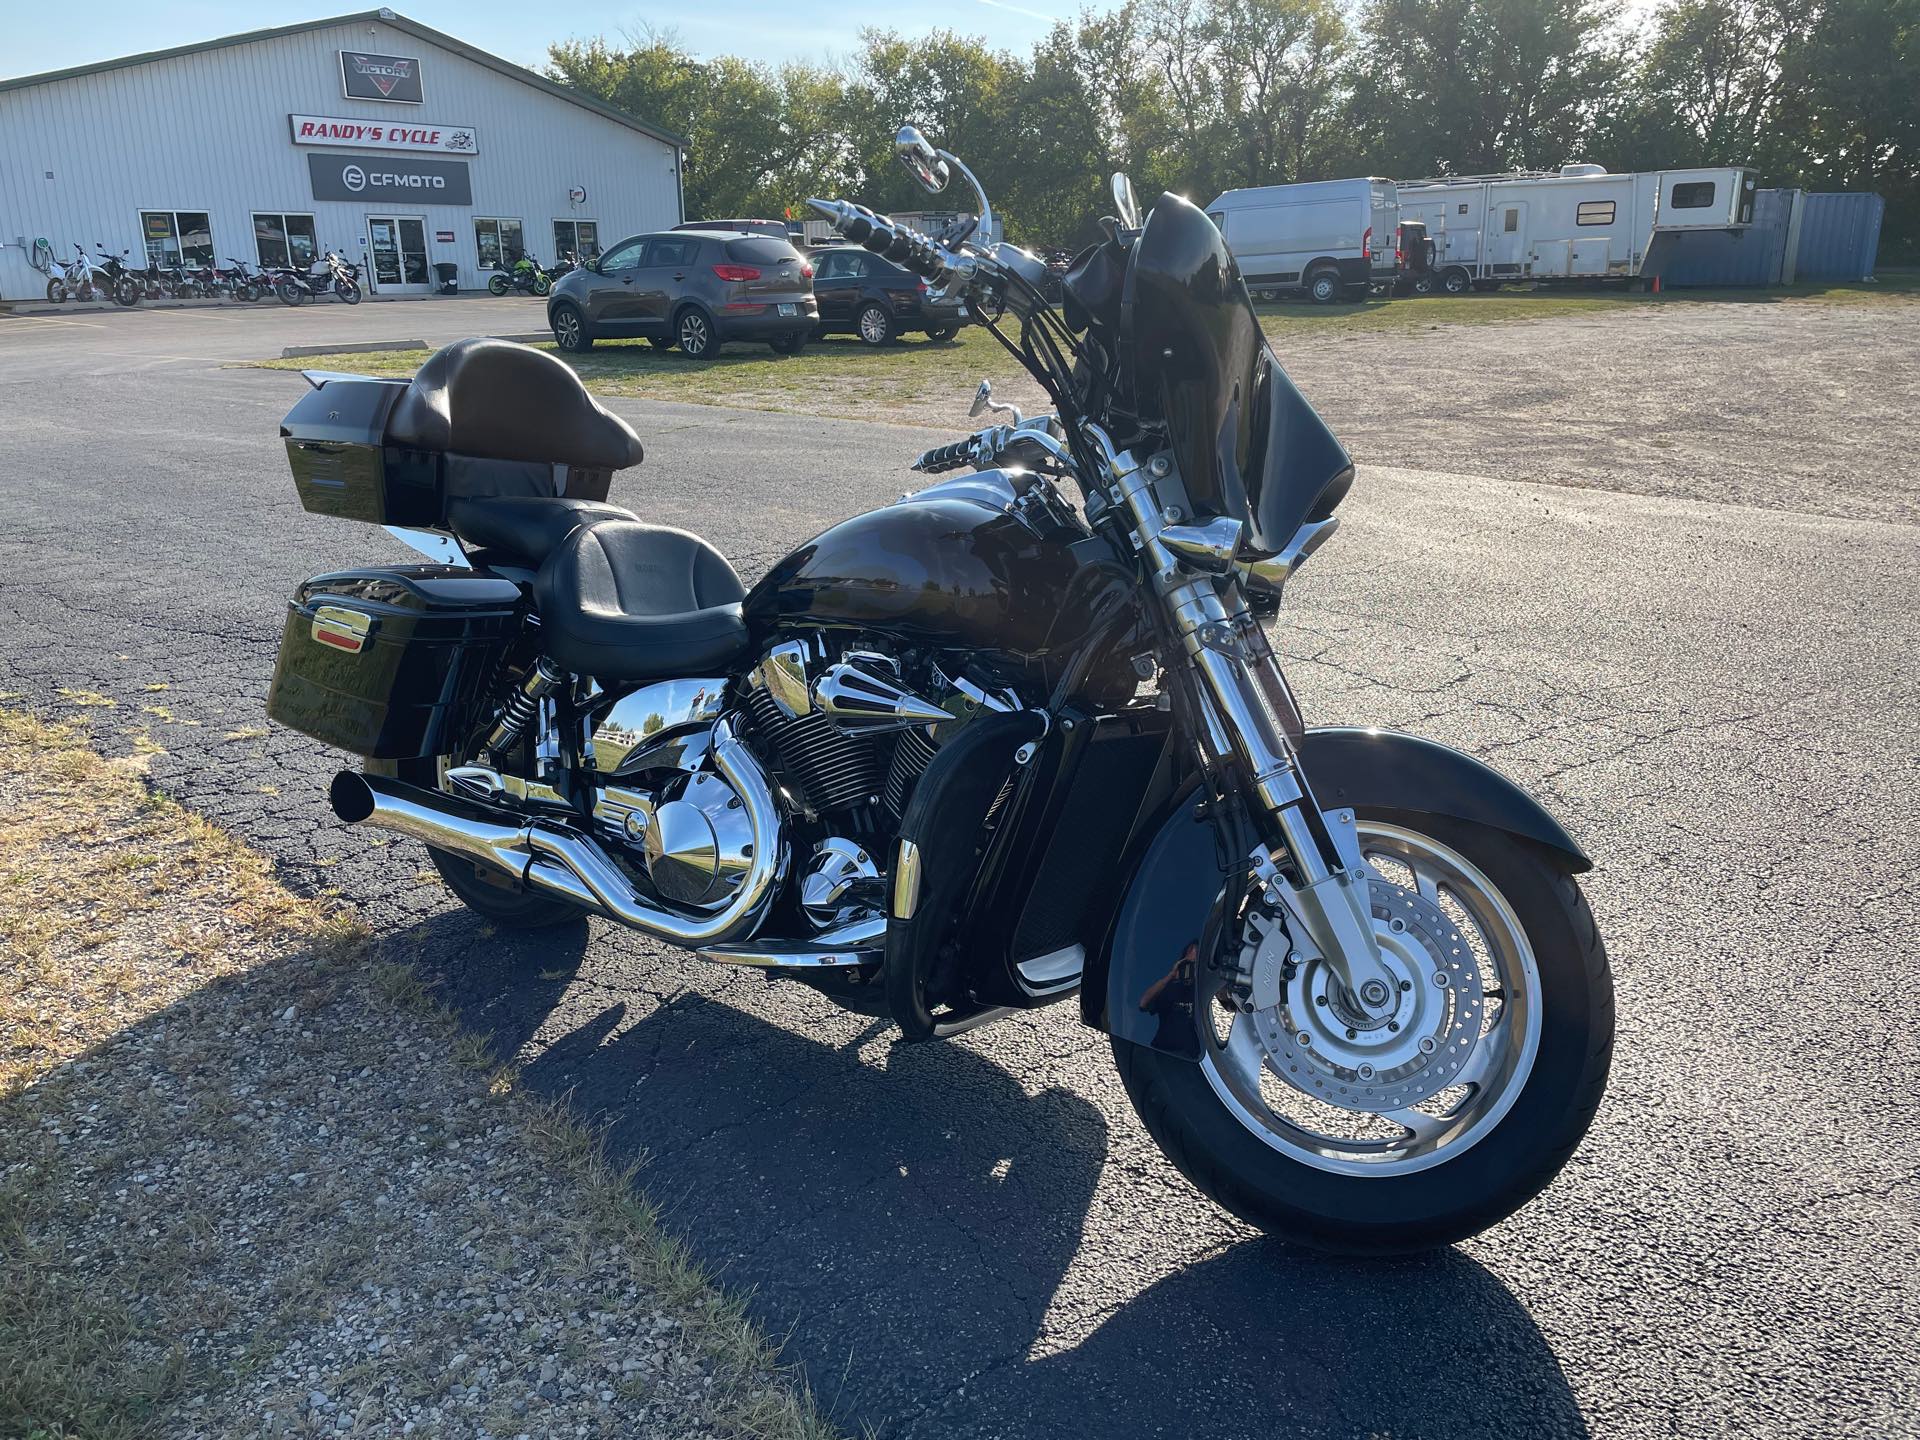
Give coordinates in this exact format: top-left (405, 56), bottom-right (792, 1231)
top-left (547, 230), bottom-right (820, 359)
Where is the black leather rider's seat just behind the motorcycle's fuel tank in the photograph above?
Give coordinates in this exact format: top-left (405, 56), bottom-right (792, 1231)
top-left (534, 520), bottom-right (747, 684)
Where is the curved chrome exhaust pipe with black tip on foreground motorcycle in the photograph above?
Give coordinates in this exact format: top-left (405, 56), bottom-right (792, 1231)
top-left (328, 722), bottom-right (781, 948)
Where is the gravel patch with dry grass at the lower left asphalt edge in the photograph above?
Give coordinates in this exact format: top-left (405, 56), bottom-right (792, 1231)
top-left (0, 710), bottom-right (829, 1440)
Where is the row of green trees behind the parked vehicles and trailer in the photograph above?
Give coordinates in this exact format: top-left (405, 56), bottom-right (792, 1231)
top-left (547, 0), bottom-right (1920, 253)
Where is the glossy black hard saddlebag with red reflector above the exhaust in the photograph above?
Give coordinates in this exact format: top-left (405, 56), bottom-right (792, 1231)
top-left (267, 564), bottom-right (522, 760)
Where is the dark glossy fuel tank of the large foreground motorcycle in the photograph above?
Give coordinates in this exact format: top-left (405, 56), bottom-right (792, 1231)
top-left (745, 486), bottom-right (1091, 659)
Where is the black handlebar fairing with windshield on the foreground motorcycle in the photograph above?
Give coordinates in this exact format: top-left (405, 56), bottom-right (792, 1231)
top-left (1121, 194), bottom-right (1354, 555)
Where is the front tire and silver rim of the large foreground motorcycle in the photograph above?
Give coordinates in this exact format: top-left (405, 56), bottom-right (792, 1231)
top-left (1114, 810), bottom-right (1613, 1254)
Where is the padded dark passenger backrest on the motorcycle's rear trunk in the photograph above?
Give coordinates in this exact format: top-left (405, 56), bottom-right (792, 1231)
top-left (386, 338), bottom-right (645, 470)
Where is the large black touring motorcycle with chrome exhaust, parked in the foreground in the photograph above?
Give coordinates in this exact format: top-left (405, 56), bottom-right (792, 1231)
top-left (269, 127), bottom-right (1613, 1254)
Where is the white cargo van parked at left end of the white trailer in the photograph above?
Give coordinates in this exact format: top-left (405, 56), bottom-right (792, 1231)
top-left (1206, 177), bottom-right (1400, 303)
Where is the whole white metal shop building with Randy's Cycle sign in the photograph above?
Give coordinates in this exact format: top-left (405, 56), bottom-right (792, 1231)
top-left (0, 10), bottom-right (684, 300)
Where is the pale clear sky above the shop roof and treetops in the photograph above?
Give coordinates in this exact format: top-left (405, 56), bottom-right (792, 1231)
top-left (0, 0), bottom-right (1079, 79)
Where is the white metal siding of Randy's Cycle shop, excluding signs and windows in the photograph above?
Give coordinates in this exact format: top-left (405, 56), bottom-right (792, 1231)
top-left (0, 23), bottom-right (682, 300)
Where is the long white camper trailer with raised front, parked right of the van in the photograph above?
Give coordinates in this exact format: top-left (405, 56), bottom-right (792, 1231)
top-left (1400, 165), bottom-right (1759, 294)
